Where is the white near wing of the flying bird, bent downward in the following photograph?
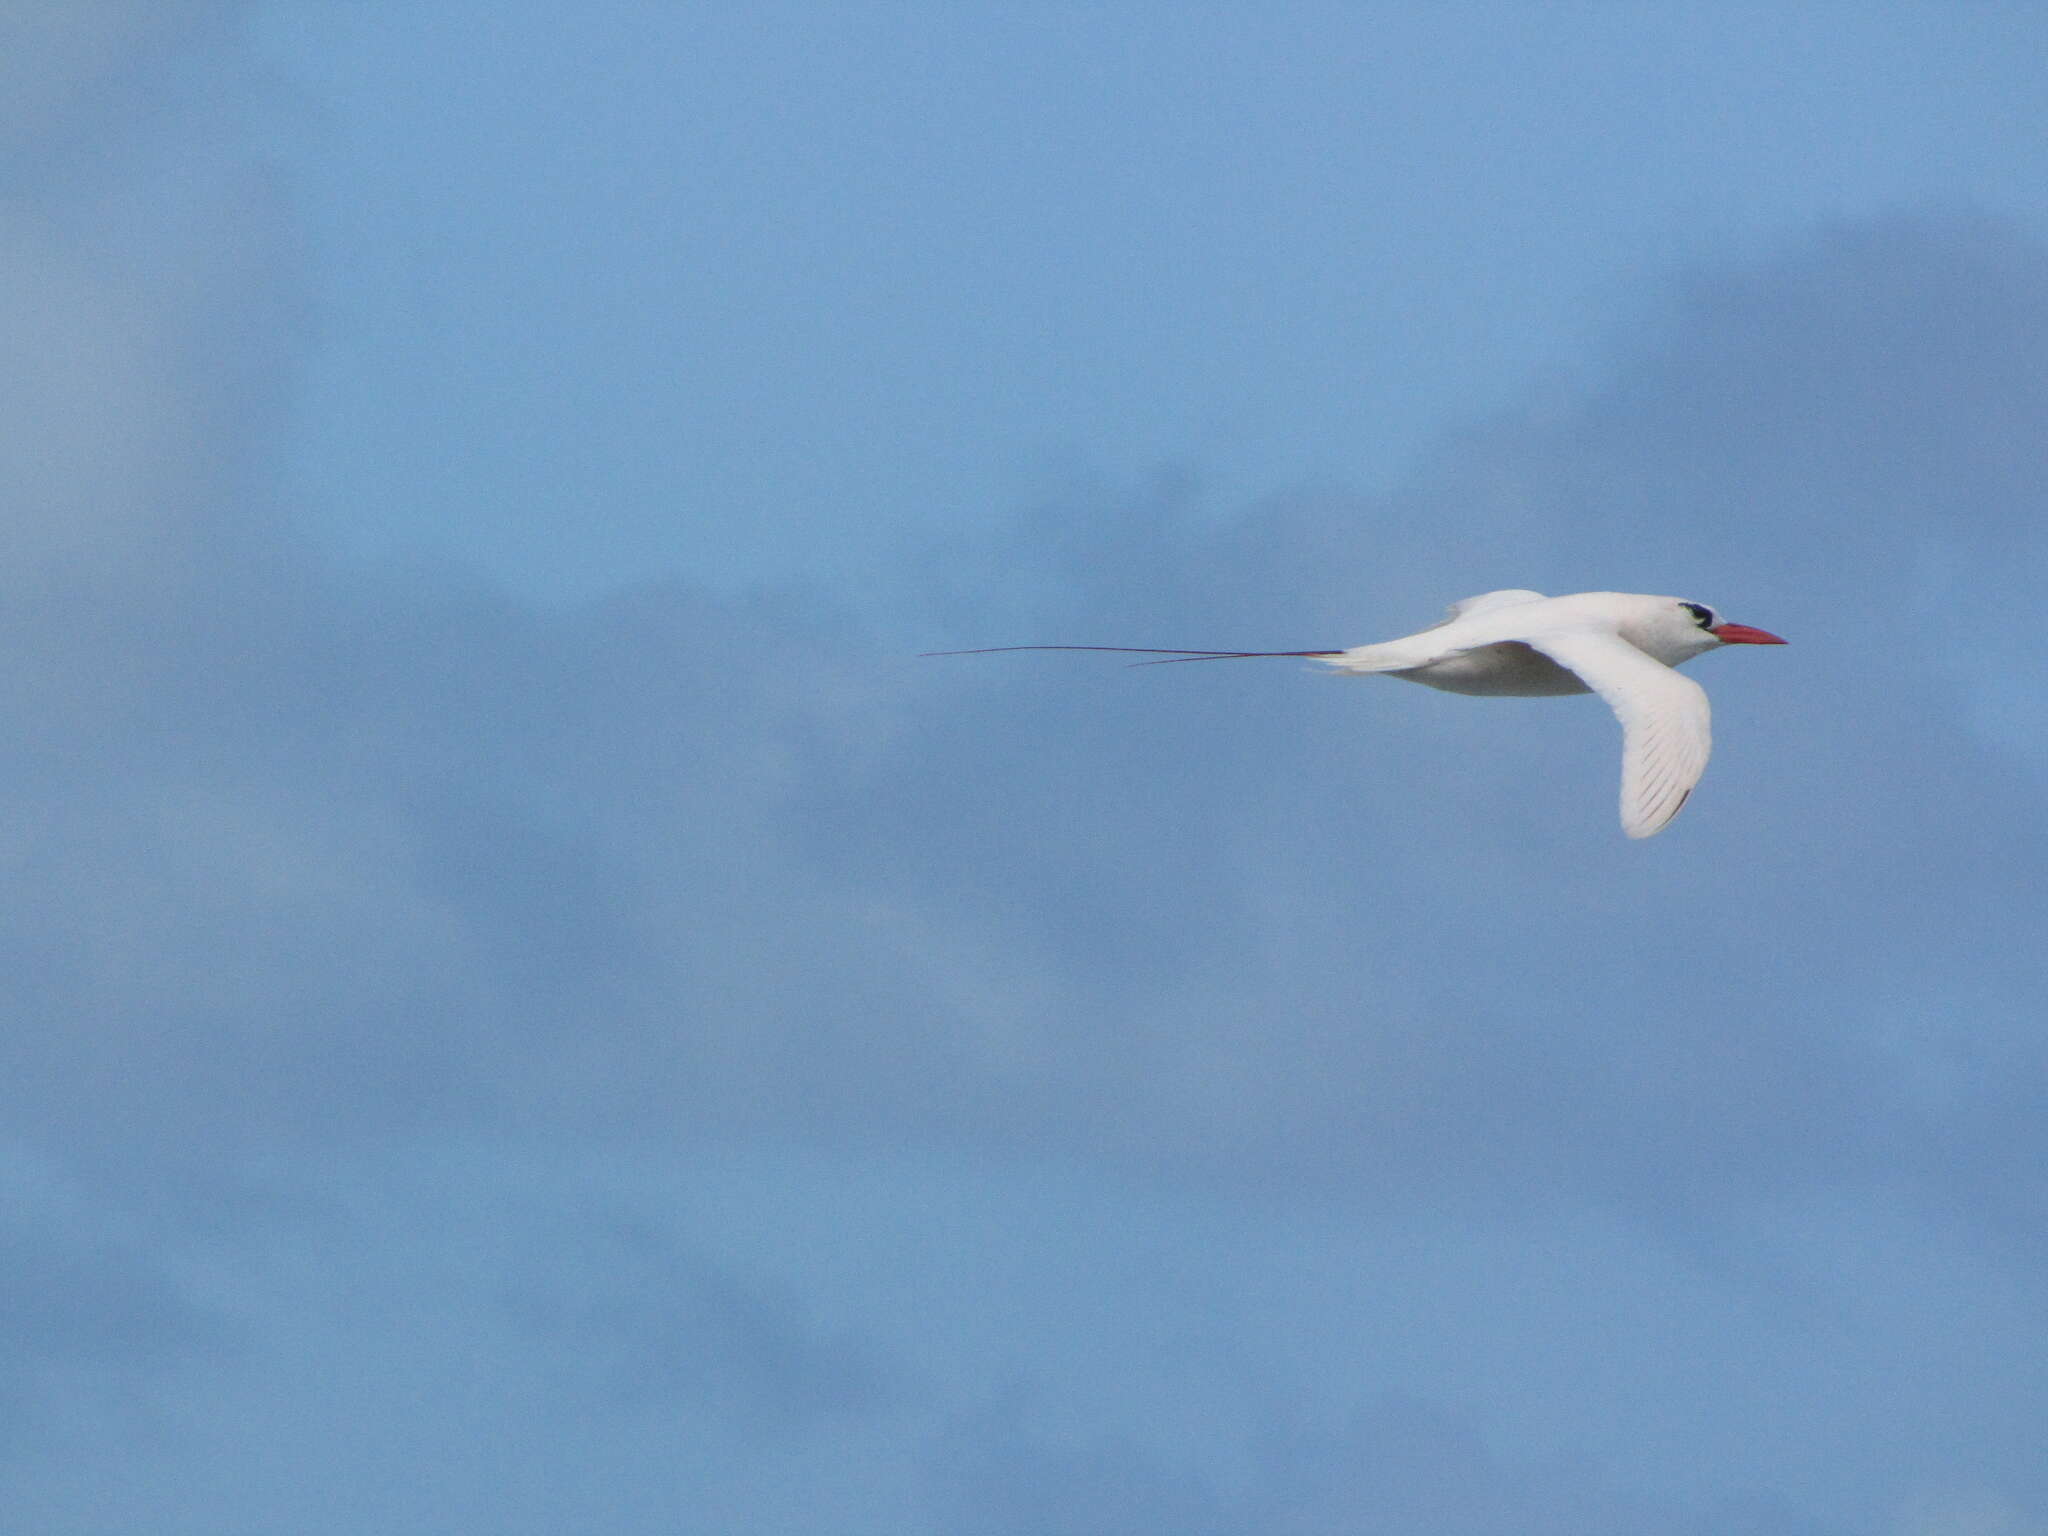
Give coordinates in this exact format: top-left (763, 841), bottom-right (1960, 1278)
top-left (1528, 629), bottom-right (1712, 838)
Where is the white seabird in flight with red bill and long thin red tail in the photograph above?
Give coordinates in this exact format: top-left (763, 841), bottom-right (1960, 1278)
top-left (928, 588), bottom-right (1786, 838)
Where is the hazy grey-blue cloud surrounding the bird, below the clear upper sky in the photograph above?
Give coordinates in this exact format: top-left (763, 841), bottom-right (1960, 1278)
top-left (0, 8), bottom-right (2048, 1536)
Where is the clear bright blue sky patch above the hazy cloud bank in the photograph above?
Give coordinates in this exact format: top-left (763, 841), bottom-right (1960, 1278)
top-left (254, 4), bottom-right (2048, 594)
